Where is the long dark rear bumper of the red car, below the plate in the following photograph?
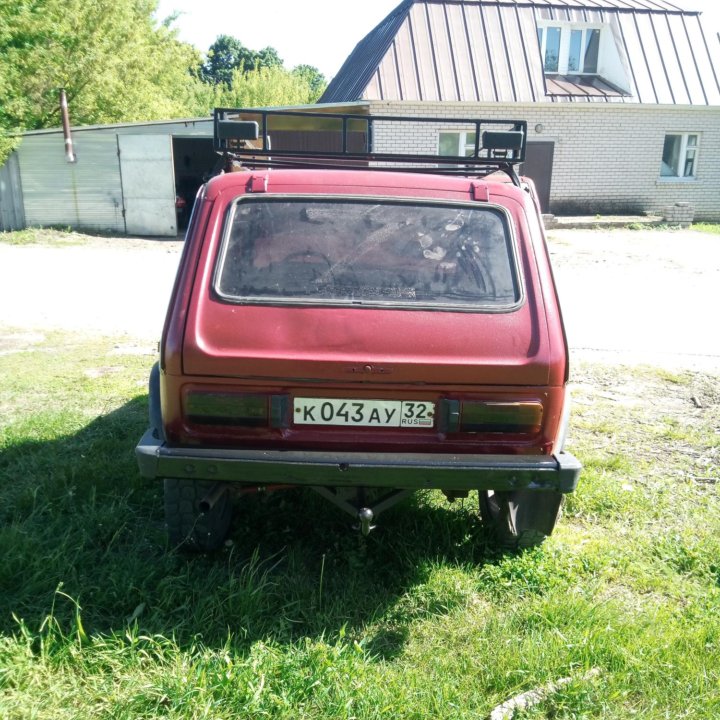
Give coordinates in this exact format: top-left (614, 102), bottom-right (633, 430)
top-left (135, 430), bottom-right (582, 493)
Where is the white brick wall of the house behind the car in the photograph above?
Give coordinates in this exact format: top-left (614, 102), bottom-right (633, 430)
top-left (370, 101), bottom-right (720, 222)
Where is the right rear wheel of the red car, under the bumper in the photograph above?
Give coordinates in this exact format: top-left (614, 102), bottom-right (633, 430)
top-left (478, 490), bottom-right (563, 550)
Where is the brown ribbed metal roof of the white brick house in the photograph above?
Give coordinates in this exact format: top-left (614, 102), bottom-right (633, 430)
top-left (320, 0), bottom-right (720, 105)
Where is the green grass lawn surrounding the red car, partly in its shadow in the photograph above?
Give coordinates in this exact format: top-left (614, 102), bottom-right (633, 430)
top-left (0, 335), bottom-right (720, 720)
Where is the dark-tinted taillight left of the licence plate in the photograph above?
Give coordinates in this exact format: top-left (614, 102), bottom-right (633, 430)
top-left (185, 390), bottom-right (287, 427)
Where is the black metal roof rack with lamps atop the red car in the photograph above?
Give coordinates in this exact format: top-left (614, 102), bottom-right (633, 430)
top-left (214, 108), bottom-right (527, 185)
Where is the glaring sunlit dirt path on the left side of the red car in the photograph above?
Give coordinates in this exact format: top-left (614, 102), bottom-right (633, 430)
top-left (0, 236), bottom-right (182, 342)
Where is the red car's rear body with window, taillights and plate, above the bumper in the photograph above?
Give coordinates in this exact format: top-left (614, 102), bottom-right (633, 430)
top-left (165, 172), bottom-right (566, 453)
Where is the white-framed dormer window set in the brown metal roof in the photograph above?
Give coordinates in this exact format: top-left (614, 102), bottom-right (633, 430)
top-left (538, 25), bottom-right (600, 75)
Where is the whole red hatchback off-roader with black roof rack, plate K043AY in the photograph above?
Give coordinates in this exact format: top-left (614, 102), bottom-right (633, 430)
top-left (136, 110), bottom-right (580, 550)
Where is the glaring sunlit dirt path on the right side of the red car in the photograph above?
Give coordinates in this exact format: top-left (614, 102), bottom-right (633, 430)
top-left (550, 230), bottom-right (720, 371)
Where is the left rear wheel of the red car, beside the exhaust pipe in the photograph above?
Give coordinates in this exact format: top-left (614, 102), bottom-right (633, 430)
top-left (164, 478), bottom-right (232, 552)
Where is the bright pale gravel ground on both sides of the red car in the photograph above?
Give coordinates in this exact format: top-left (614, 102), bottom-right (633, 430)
top-left (0, 230), bottom-right (720, 371)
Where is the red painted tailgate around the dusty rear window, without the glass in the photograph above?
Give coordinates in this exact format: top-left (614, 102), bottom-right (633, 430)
top-left (183, 172), bottom-right (549, 386)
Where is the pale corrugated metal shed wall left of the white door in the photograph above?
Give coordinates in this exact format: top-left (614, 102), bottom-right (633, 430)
top-left (18, 133), bottom-right (125, 233)
